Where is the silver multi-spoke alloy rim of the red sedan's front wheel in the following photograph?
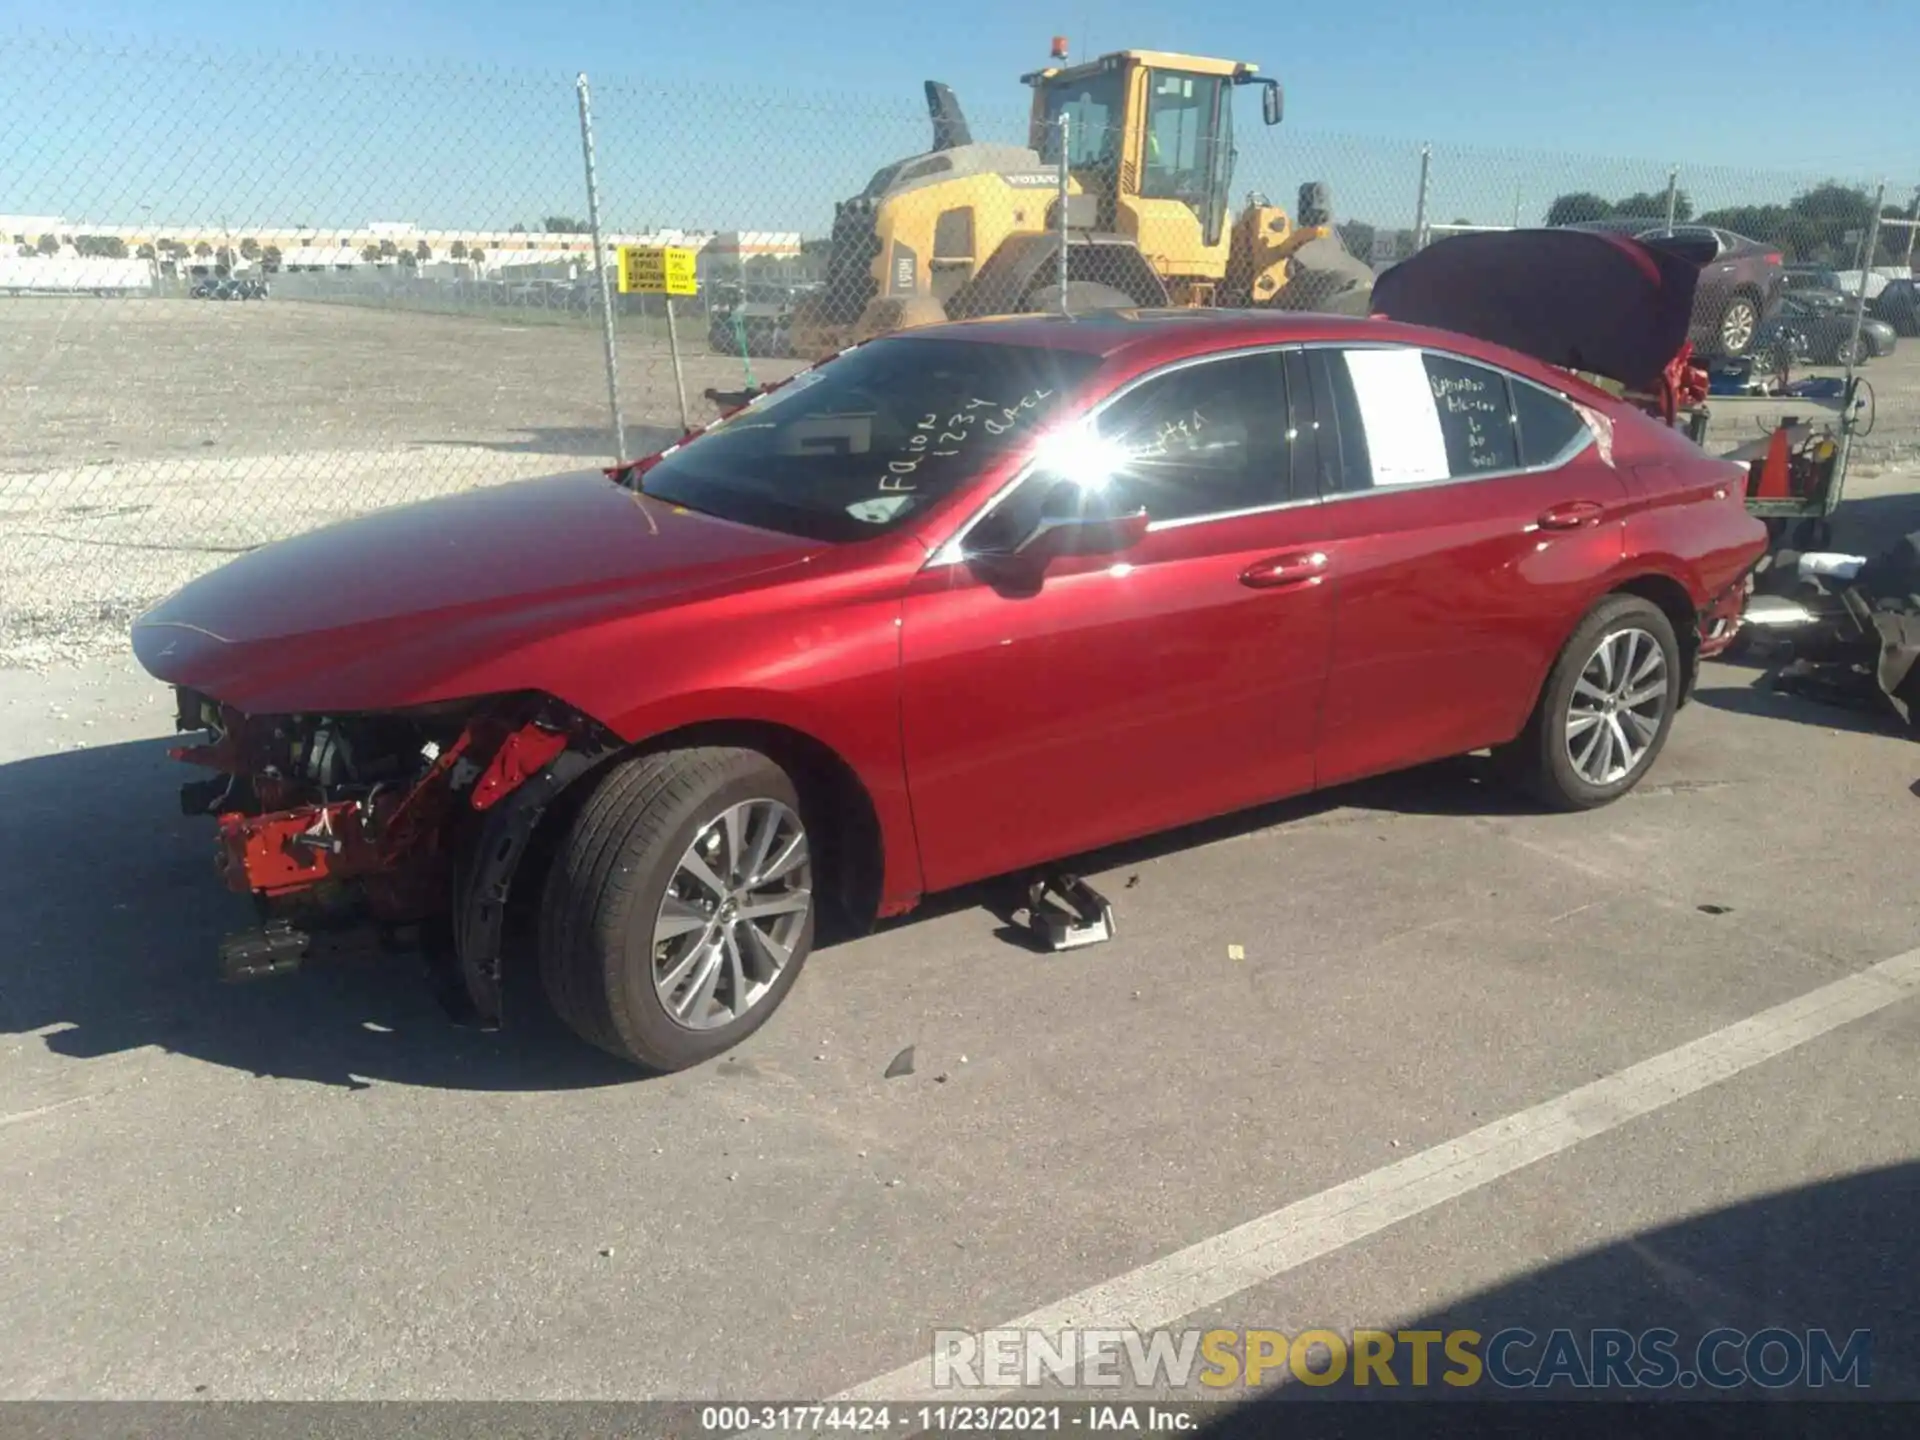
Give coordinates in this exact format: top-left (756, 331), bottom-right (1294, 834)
top-left (653, 801), bottom-right (814, 1029)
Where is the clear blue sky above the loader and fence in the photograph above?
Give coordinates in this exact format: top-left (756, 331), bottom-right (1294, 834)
top-left (0, 0), bottom-right (1920, 228)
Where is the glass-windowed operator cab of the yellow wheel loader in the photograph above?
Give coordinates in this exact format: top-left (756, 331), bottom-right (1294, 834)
top-left (1021, 44), bottom-right (1281, 280)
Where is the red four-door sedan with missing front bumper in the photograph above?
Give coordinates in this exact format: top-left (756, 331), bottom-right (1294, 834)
top-left (132, 289), bottom-right (1764, 1069)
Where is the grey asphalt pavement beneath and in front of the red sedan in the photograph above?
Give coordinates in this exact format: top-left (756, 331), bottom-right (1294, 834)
top-left (0, 637), bottom-right (1920, 1400)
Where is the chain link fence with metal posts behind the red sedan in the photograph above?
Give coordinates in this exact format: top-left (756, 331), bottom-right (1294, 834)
top-left (0, 35), bottom-right (1920, 664)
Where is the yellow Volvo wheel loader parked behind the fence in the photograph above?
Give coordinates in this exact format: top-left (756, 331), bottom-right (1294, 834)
top-left (789, 40), bottom-right (1373, 359)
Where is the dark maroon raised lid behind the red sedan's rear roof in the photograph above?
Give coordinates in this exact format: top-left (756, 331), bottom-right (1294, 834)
top-left (1373, 230), bottom-right (1699, 392)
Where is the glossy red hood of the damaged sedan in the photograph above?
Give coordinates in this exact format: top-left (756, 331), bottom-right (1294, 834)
top-left (132, 470), bottom-right (822, 714)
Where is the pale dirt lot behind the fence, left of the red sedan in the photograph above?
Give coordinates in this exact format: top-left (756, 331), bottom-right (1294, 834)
top-left (0, 300), bottom-right (793, 664)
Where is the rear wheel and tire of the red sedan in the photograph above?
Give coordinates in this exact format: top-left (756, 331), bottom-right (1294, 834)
top-left (1496, 595), bottom-right (1684, 810)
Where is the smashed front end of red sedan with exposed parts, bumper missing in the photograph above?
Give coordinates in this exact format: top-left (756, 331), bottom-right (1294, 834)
top-left (171, 687), bottom-right (618, 1027)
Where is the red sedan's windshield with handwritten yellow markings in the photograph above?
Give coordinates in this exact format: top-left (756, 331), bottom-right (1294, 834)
top-left (641, 336), bottom-right (1100, 541)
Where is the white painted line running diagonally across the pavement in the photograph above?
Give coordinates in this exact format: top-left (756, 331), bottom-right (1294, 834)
top-left (833, 950), bottom-right (1920, 1404)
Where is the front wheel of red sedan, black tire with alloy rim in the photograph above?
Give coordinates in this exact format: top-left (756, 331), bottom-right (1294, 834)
top-left (540, 747), bottom-right (814, 1073)
